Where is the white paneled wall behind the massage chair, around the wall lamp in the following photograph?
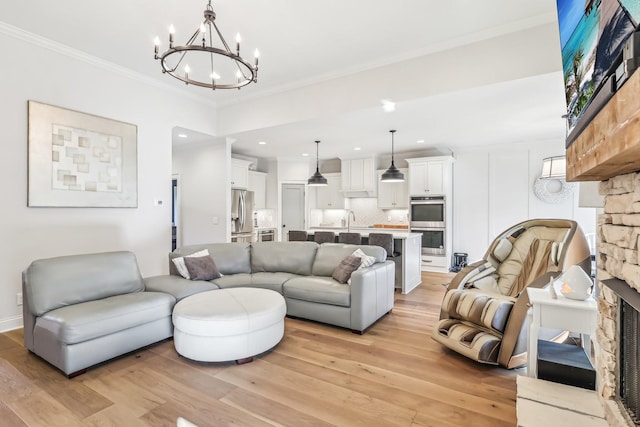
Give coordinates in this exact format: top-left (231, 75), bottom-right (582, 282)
top-left (453, 141), bottom-right (596, 261)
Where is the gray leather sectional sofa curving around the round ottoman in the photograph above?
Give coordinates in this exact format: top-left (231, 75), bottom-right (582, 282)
top-left (22, 242), bottom-right (395, 376)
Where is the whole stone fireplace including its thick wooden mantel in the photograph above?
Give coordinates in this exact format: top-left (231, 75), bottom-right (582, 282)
top-left (567, 61), bottom-right (640, 427)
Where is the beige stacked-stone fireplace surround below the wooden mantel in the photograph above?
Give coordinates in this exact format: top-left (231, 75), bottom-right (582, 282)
top-left (596, 173), bottom-right (640, 426)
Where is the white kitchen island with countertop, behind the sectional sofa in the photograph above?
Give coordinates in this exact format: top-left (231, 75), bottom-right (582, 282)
top-left (307, 227), bottom-right (422, 294)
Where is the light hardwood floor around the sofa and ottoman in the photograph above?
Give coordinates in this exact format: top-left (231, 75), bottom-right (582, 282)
top-left (0, 273), bottom-right (516, 427)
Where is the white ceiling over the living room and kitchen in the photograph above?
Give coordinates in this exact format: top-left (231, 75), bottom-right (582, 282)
top-left (0, 0), bottom-right (565, 158)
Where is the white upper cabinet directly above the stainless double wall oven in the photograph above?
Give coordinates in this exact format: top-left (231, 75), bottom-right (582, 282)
top-left (407, 156), bottom-right (452, 196)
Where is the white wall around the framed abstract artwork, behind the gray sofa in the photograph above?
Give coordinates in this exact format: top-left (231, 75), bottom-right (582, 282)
top-left (0, 26), bottom-right (219, 331)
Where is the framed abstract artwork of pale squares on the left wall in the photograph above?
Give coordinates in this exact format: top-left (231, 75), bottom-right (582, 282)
top-left (28, 101), bottom-right (138, 207)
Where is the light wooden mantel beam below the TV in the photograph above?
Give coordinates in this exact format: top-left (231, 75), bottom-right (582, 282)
top-left (567, 72), bottom-right (640, 181)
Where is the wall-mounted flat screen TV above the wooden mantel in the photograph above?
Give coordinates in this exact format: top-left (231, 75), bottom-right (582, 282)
top-left (556, 0), bottom-right (640, 147)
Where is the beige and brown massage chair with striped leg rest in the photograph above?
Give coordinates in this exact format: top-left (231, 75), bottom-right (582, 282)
top-left (432, 219), bottom-right (591, 369)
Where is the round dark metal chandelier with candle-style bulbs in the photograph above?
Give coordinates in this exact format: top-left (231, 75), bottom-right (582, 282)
top-left (154, 0), bottom-right (260, 90)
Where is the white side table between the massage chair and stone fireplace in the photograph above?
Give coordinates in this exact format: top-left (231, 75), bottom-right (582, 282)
top-left (527, 288), bottom-right (598, 378)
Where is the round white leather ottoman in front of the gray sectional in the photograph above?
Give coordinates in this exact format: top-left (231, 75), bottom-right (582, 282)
top-left (173, 288), bottom-right (287, 363)
